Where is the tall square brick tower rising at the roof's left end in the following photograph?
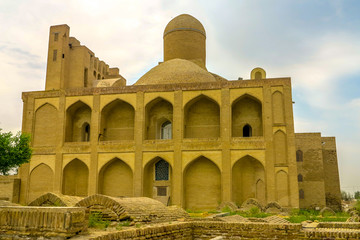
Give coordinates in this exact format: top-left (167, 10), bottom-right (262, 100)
top-left (45, 24), bottom-right (70, 90)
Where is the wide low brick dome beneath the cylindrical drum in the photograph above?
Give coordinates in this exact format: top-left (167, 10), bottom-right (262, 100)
top-left (134, 58), bottom-right (217, 85)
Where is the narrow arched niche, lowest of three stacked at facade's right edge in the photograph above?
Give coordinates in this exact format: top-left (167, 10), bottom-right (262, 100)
top-left (275, 170), bottom-right (289, 207)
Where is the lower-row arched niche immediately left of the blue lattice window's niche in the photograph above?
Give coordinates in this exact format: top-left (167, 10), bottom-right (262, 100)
top-left (99, 158), bottom-right (134, 197)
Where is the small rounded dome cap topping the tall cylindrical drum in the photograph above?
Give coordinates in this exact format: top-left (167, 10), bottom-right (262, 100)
top-left (164, 14), bottom-right (206, 37)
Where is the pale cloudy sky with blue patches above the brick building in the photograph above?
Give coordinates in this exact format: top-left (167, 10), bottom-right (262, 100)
top-left (0, 0), bottom-right (360, 192)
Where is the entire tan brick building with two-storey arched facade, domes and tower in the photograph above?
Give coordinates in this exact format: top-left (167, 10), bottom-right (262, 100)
top-left (20, 14), bottom-right (340, 209)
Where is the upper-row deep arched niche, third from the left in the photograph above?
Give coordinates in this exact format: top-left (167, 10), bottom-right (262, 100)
top-left (100, 99), bottom-right (135, 141)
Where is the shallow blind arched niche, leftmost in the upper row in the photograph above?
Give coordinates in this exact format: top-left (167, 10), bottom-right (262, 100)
top-left (33, 103), bottom-right (58, 146)
